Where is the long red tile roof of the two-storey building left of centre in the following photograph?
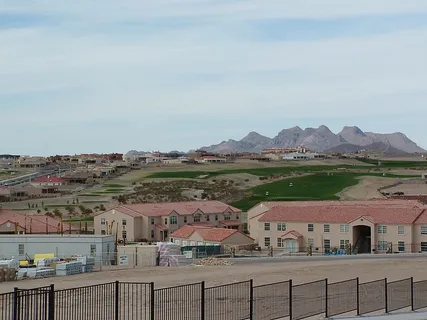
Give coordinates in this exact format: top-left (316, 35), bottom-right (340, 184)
top-left (106, 201), bottom-right (242, 217)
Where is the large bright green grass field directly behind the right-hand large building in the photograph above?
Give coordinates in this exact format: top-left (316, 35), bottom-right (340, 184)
top-left (231, 173), bottom-right (408, 211)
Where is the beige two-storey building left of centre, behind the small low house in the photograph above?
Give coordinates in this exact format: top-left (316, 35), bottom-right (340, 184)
top-left (94, 201), bottom-right (242, 241)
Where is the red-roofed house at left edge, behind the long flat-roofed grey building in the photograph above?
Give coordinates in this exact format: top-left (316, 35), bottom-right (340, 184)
top-left (0, 208), bottom-right (79, 234)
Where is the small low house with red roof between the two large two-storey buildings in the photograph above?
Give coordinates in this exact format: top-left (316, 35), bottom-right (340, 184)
top-left (170, 225), bottom-right (255, 247)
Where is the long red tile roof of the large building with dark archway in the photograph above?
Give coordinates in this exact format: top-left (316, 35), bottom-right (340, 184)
top-left (259, 200), bottom-right (427, 224)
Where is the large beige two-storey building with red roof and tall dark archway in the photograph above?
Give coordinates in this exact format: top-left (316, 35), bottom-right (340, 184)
top-left (248, 199), bottom-right (427, 253)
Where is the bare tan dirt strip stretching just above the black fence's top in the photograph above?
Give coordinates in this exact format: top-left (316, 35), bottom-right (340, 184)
top-left (0, 257), bottom-right (427, 293)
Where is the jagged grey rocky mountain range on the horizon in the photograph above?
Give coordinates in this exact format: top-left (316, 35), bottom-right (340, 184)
top-left (200, 125), bottom-right (426, 154)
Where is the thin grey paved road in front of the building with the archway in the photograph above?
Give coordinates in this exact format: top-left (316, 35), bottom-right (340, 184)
top-left (228, 253), bottom-right (427, 265)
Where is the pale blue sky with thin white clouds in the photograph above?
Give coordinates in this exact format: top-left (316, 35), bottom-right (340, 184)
top-left (0, 0), bottom-right (427, 155)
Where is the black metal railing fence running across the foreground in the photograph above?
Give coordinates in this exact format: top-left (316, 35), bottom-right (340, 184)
top-left (0, 278), bottom-right (427, 320)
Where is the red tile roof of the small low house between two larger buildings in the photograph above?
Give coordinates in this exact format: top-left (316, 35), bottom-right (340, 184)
top-left (170, 225), bottom-right (253, 242)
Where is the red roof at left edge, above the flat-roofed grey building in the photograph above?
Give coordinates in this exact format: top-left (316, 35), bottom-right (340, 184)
top-left (0, 209), bottom-right (78, 233)
